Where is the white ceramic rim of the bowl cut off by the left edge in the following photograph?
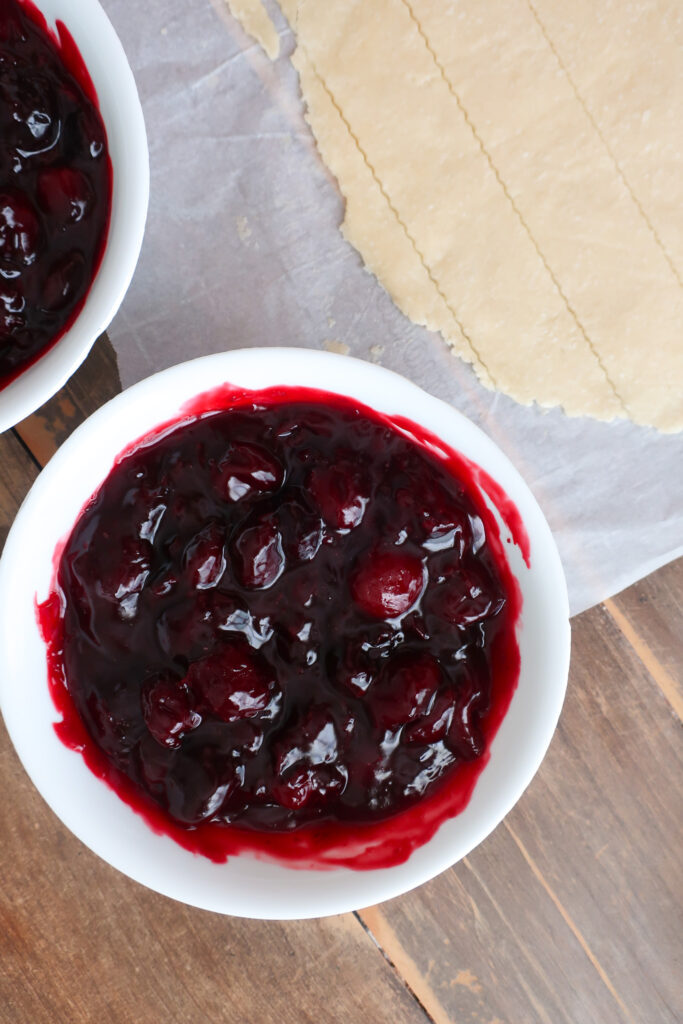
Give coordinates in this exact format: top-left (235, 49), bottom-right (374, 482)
top-left (0, 0), bottom-right (150, 432)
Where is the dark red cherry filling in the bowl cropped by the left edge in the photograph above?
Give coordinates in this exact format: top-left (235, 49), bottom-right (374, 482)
top-left (0, 0), bottom-right (112, 388)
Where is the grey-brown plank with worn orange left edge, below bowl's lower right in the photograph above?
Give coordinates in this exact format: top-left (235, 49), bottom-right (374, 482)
top-left (361, 828), bottom-right (624, 1024)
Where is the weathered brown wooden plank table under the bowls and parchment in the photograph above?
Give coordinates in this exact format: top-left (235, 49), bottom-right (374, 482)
top-left (0, 339), bottom-right (683, 1024)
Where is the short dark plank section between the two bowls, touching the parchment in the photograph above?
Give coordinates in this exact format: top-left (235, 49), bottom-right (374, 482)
top-left (14, 334), bottom-right (121, 466)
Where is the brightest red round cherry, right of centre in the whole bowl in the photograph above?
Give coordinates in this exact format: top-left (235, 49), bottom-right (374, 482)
top-left (351, 548), bottom-right (424, 618)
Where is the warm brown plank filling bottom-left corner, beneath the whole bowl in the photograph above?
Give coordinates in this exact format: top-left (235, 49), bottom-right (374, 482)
top-left (0, 725), bottom-right (428, 1024)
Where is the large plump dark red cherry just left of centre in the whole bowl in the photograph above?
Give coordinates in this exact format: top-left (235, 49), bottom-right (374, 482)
top-left (185, 639), bottom-right (279, 722)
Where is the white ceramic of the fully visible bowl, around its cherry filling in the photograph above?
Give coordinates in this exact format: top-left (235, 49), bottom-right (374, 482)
top-left (0, 348), bottom-right (569, 919)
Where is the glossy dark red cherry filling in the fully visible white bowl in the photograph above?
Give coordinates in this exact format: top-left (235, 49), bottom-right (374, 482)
top-left (37, 385), bottom-right (521, 869)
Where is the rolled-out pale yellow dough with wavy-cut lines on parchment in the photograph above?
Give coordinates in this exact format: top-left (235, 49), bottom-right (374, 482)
top-left (229, 0), bottom-right (683, 431)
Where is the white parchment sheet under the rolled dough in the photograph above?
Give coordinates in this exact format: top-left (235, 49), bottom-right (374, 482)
top-left (102, 0), bottom-right (683, 613)
